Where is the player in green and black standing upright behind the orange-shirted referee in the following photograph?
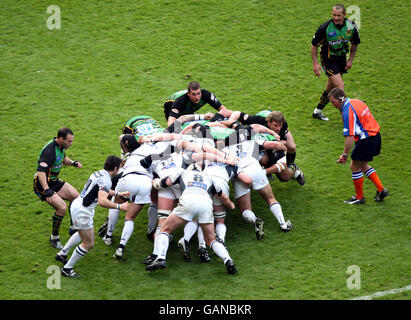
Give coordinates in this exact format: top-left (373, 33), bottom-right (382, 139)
top-left (311, 4), bottom-right (360, 121)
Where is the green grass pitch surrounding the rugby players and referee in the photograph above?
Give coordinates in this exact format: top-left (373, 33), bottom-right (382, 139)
top-left (0, 0), bottom-right (411, 300)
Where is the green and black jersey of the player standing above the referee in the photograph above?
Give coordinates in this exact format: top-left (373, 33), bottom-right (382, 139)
top-left (311, 19), bottom-right (360, 58)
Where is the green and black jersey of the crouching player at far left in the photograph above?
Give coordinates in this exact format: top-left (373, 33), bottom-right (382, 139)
top-left (37, 138), bottom-right (66, 181)
